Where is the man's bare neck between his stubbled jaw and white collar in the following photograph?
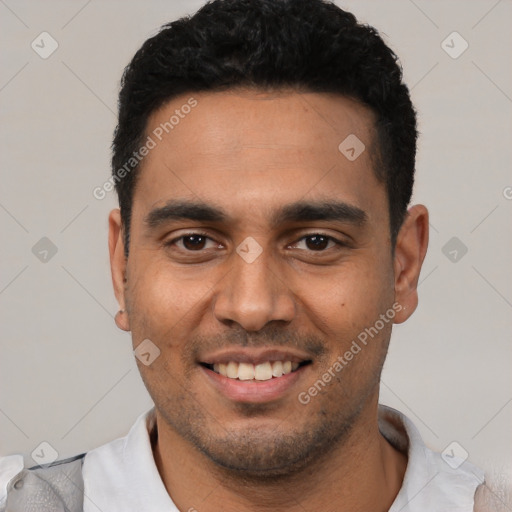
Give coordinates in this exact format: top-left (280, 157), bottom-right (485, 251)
top-left (154, 399), bottom-right (407, 512)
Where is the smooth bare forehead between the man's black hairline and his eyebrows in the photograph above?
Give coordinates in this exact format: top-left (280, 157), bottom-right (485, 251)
top-left (134, 90), bottom-right (384, 224)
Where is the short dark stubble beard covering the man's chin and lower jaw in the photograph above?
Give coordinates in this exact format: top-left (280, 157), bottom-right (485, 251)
top-left (155, 374), bottom-right (372, 482)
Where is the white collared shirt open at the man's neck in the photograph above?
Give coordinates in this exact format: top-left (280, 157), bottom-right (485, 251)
top-left (0, 405), bottom-right (484, 512)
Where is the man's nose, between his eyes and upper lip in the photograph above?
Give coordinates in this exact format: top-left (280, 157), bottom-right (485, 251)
top-left (214, 244), bottom-right (296, 331)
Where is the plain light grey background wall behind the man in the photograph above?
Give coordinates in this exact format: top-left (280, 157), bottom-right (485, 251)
top-left (0, 0), bottom-right (512, 488)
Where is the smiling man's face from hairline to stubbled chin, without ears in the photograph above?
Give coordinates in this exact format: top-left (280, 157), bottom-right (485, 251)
top-left (112, 91), bottom-right (412, 475)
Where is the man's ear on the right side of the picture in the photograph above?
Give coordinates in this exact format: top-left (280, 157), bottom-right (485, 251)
top-left (393, 204), bottom-right (429, 324)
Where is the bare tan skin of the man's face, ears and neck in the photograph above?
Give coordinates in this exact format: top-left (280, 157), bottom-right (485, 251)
top-left (109, 90), bottom-right (428, 512)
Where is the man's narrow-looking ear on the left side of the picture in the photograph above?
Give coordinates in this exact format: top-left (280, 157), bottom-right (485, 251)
top-left (108, 208), bottom-right (130, 331)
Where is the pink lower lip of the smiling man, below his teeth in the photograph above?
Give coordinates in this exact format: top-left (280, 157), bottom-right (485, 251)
top-left (200, 365), bottom-right (310, 403)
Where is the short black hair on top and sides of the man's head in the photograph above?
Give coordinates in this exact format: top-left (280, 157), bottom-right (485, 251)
top-left (112, 0), bottom-right (417, 255)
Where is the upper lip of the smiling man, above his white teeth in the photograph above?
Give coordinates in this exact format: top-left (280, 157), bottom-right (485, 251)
top-left (199, 347), bottom-right (312, 365)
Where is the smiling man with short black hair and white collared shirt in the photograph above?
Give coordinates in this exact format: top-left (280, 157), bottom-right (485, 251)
top-left (3, 0), bottom-right (492, 512)
